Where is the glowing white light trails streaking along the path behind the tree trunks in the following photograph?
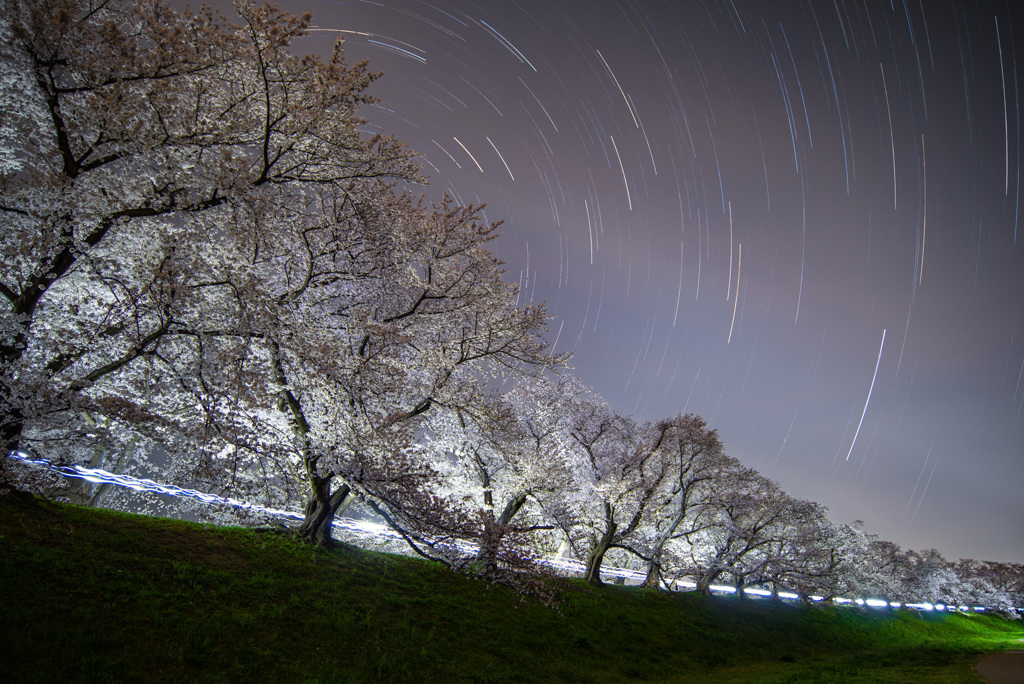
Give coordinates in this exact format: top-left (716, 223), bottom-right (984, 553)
top-left (4, 453), bottom-right (1024, 614)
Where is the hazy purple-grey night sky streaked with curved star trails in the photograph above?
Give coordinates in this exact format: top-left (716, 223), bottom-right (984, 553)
top-left (251, 0), bottom-right (1024, 562)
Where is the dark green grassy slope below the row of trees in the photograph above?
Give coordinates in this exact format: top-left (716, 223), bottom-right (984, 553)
top-left (0, 495), bottom-right (1024, 683)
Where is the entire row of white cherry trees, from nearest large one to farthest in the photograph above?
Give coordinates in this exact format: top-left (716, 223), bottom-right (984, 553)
top-left (0, 0), bottom-right (1024, 605)
